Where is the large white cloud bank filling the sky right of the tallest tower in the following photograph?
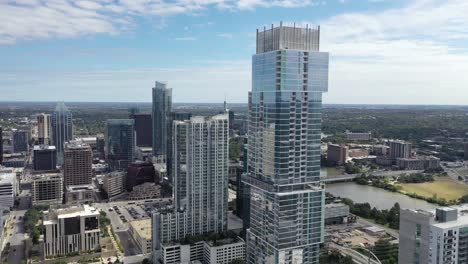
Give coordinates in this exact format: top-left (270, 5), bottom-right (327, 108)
top-left (320, 0), bottom-right (468, 104)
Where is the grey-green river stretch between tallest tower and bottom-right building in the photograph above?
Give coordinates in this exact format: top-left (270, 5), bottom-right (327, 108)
top-left (325, 182), bottom-right (438, 210)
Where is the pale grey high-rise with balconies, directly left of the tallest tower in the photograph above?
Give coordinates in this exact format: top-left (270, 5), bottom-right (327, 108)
top-left (153, 114), bottom-right (229, 258)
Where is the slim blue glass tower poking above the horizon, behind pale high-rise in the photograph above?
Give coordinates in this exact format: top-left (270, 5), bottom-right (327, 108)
top-left (153, 82), bottom-right (172, 156)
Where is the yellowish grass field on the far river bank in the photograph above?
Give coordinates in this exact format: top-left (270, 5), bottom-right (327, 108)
top-left (400, 177), bottom-right (468, 200)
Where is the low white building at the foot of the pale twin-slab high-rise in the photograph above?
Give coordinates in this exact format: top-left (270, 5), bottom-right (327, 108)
top-left (161, 237), bottom-right (245, 264)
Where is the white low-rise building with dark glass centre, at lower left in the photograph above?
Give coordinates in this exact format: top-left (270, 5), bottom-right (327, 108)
top-left (43, 205), bottom-right (101, 258)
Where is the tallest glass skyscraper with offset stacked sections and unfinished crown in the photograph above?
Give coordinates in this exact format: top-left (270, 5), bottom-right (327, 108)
top-left (243, 23), bottom-right (329, 264)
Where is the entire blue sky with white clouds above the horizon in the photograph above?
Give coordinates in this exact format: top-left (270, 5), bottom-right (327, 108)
top-left (0, 0), bottom-right (468, 105)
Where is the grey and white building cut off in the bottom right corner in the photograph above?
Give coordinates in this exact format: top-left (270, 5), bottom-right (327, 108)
top-left (398, 205), bottom-right (468, 264)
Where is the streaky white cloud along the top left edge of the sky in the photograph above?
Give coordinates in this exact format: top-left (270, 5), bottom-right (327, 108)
top-left (0, 0), bottom-right (318, 44)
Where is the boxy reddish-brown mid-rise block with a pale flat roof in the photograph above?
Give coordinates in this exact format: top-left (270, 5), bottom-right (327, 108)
top-left (63, 141), bottom-right (93, 187)
